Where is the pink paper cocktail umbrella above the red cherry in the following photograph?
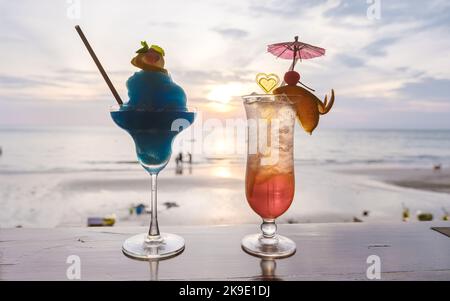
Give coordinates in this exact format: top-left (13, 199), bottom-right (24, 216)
top-left (267, 36), bottom-right (325, 90)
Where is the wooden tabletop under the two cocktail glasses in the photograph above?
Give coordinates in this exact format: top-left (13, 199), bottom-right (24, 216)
top-left (0, 222), bottom-right (450, 280)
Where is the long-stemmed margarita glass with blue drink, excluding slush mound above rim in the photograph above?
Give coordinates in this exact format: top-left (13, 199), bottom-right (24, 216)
top-left (110, 105), bottom-right (196, 260)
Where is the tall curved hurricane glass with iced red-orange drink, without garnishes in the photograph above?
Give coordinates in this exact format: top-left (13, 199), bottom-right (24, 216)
top-left (242, 95), bottom-right (296, 258)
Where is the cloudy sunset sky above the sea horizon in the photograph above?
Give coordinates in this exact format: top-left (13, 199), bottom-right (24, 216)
top-left (0, 0), bottom-right (450, 129)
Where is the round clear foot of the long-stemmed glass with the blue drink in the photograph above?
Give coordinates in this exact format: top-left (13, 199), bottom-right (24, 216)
top-left (122, 233), bottom-right (184, 260)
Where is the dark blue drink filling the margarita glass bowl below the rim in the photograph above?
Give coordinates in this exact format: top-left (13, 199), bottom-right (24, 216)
top-left (111, 109), bottom-right (195, 173)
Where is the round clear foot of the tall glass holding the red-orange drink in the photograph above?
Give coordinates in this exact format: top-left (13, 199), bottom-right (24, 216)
top-left (242, 234), bottom-right (296, 258)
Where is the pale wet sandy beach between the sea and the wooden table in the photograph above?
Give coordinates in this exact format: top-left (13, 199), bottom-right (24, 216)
top-left (0, 160), bottom-right (450, 227)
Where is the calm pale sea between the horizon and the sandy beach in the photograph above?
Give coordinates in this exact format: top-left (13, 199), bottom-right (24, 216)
top-left (0, 127), bottom-right (450, 174)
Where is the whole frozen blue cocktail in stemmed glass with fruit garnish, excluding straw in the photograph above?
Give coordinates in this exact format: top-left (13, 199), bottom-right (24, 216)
top-left (111, 42), bottom-right (195, 259)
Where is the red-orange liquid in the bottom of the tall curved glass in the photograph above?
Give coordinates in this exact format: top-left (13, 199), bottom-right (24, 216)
top-left (245, 167), bottom-right (295, 219)
